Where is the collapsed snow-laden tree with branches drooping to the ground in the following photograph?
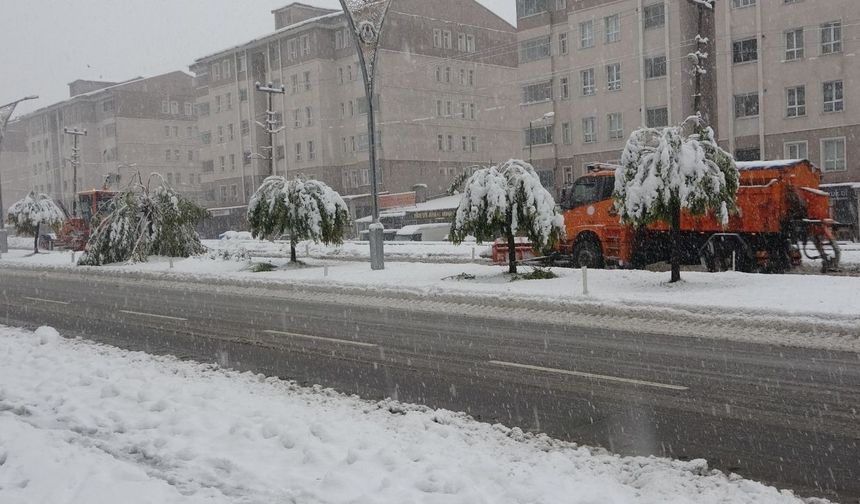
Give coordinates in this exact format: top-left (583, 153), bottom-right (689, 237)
top-left (78, 173), bottom-right (207, 266)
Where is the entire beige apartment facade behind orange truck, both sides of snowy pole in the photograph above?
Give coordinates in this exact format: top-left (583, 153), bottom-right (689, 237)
top-left (517, 0), bottom-right (860, 189)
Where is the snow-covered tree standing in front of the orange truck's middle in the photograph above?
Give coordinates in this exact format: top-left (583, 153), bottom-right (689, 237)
top-left (614, 116), bottom-right (738, 282)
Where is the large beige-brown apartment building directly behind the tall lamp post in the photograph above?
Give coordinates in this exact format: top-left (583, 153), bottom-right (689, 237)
top-left (190, 0), bottom-right (520, 216)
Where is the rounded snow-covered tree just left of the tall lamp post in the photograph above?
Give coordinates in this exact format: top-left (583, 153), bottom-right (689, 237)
top-left (248, 176), bottom-right (349, 262)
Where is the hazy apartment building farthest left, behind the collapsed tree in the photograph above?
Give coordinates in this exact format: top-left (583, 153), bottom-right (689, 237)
top-left (0, 72), bottom-right (200, 209)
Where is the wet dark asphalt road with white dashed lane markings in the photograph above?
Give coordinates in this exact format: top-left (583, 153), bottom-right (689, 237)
top-left (0, 268), bottom-right (860, 498)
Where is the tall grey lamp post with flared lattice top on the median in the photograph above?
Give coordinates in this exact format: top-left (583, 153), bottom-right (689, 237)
top-left (340, 0), bottom-right (391, 270)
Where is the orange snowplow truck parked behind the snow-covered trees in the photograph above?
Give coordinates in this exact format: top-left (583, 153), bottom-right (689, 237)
top-left (494, 160), bottom-right (839, 273)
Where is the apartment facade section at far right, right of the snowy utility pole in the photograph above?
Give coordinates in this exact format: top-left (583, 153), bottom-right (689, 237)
top-left (715, 0), bottom-right (860, 183)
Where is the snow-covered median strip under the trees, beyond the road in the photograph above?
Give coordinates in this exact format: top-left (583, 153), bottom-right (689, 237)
top-left (0, 250), bottom-right (860, 322)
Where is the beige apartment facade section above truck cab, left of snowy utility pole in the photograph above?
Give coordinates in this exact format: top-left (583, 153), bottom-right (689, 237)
top-left (517, 0), bottom-right (718, 190)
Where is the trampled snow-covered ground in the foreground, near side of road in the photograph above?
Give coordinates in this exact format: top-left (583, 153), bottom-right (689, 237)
top-left (0, 326), bottom-right (824, 504)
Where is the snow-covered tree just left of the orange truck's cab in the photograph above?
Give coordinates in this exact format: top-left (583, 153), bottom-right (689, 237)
top-left (450, 159), bottom-right (564, 273)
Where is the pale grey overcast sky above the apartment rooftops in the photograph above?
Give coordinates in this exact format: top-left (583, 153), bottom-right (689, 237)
top-left (0, 0), bottom-right (516, 115)
